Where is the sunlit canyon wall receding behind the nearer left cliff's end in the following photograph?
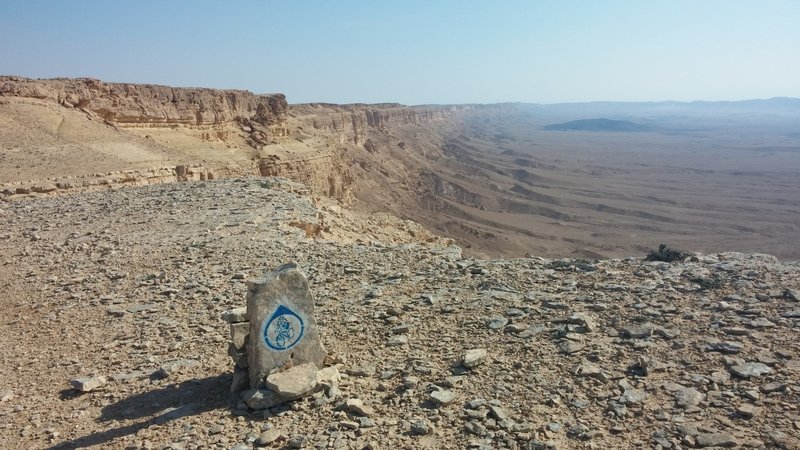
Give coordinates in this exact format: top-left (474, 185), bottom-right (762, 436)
top-left (250, 103), bottom-right (468, 203)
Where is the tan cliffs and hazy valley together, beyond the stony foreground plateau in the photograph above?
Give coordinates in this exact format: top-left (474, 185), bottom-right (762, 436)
top-left (0, 77), bottom-right (800, 259)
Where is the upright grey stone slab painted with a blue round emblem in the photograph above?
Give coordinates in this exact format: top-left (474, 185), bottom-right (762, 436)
top-left (247, 264), bottom-right (325, 389)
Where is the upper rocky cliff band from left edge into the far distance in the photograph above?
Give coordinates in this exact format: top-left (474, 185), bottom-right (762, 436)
top-left (0, 76), bottom-right (471, 149)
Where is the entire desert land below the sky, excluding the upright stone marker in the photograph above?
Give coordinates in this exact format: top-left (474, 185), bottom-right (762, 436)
top-left (0, 76), bottom-right (800, 450)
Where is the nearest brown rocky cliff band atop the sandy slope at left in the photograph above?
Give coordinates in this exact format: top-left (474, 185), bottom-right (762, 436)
top-left (0, 77), bottom-right (288, 142)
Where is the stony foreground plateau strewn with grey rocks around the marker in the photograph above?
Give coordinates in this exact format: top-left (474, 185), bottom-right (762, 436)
top-left (0, 178), bottom-right (800, 450)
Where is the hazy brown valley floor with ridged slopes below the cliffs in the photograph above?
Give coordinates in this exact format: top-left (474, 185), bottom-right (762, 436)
top-left (396, 106), bottom-right (800, 259)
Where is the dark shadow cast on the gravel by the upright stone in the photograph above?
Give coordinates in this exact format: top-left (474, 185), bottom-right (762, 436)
top-left (49, 374), bottom-right (231, 450)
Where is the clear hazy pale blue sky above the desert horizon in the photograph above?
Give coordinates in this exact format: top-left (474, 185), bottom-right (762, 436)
top-left (0, 0), bottom-right (800, 104)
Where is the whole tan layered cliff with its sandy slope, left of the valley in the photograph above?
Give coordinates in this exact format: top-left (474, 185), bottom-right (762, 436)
top-left (0, 76), bottom-right (471, 199)
